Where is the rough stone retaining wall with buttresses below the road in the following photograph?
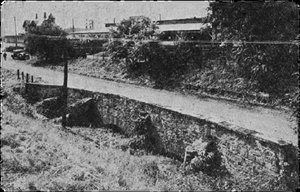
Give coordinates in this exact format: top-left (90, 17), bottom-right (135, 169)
top-left (26, 84), bottom-right (298, 190)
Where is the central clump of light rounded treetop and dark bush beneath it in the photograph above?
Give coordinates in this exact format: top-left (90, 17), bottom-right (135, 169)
top-left (108, 17), bottom-right (202, 87)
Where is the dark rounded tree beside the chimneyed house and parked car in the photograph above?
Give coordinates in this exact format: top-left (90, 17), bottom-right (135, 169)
top-left (25, 14), bottom-right (72, 62)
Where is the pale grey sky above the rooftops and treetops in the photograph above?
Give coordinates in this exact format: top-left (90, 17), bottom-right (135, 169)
top-left (1, 1), bottom-right (208, 36)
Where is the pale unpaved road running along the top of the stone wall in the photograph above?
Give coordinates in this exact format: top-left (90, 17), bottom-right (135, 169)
top-left (2, 55), bottom-right (298, 146)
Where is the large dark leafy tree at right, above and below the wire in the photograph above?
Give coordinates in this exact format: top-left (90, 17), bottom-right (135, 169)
top-left (207, 2), bottom-right (298, 97)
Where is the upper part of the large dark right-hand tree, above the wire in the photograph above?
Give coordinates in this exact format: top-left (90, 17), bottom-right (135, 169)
top-left (208, 2), bottom-right (298, 41)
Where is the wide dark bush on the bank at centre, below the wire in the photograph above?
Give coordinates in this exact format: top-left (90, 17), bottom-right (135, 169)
top-left (108, 41), bottom-right (202, 87)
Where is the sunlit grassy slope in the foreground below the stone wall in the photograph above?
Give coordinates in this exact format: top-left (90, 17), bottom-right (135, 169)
top-left (1, 70), bottom-right (210, 191)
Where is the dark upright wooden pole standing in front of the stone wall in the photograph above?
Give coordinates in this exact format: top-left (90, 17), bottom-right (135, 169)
top-left (61, 50), bottom-right (68, 128)
